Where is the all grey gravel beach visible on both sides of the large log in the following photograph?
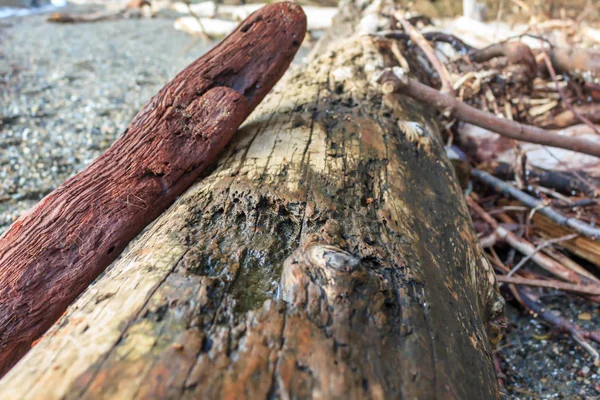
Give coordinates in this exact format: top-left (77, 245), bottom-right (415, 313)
top-left (0, 5), bottom-right (600, 399)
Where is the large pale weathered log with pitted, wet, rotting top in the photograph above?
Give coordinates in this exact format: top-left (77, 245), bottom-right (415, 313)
top-left (0, 2), bottom-right (503, 399)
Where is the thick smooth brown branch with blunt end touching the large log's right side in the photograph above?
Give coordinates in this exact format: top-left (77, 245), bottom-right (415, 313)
top-left (396, 72), bottom-right (600, 157)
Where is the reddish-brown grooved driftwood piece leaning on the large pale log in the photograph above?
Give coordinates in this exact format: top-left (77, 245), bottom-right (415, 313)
top-left (0, 3), bottom-right (306, 376)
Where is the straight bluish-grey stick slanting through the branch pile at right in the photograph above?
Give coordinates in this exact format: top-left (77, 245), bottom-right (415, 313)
top-left (471, 170), bottom-right (600, 240)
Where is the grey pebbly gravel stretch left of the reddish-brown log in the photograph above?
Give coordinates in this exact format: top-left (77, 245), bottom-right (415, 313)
top-left (0, 10), bottom-right (209, 232)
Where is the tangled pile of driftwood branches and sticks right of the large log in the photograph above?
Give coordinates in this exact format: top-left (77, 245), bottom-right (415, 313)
top-left (373, 7), bottom-right (600, 365)
